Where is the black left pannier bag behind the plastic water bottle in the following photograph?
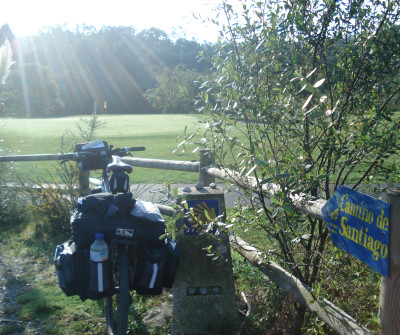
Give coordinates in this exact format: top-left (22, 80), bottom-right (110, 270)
top-left (54, 241), bottom-right (115, 301)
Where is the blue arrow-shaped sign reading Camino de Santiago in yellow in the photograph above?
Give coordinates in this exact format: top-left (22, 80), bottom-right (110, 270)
top-left (322, 186), bottom-right (390, 277)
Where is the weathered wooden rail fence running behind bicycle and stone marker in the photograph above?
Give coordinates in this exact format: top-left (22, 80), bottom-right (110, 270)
top-left (0, 151), bottom-right (400, 335)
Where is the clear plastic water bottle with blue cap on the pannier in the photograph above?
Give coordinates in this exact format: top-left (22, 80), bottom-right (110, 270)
top-left (90, 233), bottom-right (110, 292)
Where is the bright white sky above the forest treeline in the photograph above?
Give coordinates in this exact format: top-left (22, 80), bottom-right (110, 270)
top-left (0, 0), bottom-right (222, 43)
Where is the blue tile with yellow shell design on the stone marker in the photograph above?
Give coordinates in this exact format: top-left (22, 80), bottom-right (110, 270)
top-left (183, 199), bottom-right (219, 235)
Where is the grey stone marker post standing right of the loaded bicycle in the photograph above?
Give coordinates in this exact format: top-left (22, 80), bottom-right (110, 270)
top-left (172, 187), bottom-right (237, 335)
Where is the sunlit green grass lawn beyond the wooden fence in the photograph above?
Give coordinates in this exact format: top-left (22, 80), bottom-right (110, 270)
top-left (0, 115), bottom-right (204, 183)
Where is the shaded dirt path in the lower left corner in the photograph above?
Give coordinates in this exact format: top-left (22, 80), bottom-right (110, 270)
top-left (0, 241), bottom-right (43, 335)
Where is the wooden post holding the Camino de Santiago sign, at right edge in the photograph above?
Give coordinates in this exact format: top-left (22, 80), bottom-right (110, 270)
top-left (379, 188), bottom-right (400, 335)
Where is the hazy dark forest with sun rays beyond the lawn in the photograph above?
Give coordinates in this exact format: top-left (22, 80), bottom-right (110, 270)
top-left (0, 25), bottom-right (211, 118)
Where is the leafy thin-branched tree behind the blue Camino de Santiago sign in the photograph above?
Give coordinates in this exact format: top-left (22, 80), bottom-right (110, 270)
top-left (187, 0), bottom-right (400, 333)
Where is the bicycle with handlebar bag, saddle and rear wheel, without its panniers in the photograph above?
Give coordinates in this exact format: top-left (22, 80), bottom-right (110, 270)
top-left (55, 140), bottom-right (165, 335)
